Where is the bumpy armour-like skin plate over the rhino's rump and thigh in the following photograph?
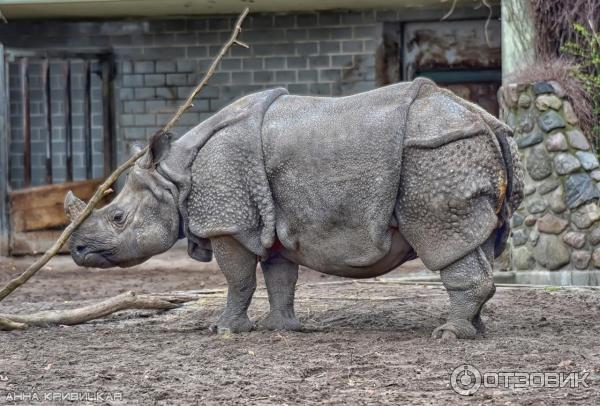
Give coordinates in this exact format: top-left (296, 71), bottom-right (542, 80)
top-left (396, 134), bottom-right (504, 270)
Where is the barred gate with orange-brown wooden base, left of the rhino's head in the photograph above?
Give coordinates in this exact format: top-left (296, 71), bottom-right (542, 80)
top-left (0, 49), bottom-right (115, 254)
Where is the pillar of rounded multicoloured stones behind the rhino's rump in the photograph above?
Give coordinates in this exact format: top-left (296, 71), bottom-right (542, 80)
top-left (499, 82), bottom-right (600, 270)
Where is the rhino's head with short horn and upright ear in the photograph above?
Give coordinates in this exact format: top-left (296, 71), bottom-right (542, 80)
top-left (64, 133), bottom-right (180, 268)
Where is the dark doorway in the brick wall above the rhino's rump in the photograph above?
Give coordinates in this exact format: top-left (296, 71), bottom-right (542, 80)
top-left (377, 19), bottom-right (502, 116)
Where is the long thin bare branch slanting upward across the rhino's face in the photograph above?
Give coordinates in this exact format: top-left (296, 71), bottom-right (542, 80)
top-left (0, 8), bottom-right (249, 301)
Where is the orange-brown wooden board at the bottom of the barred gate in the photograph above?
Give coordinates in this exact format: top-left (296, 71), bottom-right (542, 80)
top-left (9, 179), bottom-right (102, 233)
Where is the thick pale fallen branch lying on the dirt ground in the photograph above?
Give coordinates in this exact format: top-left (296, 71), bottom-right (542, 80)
top-left (0, 292), bottom-right (198, 330)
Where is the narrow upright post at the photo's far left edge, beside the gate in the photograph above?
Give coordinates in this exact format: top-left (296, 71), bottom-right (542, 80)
top-left (0, 43), bottom-right (10, 255)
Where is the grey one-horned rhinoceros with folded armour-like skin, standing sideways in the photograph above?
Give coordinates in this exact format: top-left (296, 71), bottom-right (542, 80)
top-left (65, 79), bottom-right (523, 338)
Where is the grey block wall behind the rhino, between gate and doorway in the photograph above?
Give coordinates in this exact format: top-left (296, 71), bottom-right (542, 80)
top-left (0, 10), bottom-right (398, 178)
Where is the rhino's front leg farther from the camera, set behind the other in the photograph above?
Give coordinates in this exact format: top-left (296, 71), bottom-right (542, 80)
top-left (260, 256), bottom-right (300, 331)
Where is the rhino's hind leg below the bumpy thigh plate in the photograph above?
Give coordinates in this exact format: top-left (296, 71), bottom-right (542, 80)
top-left (432, 239), bottom-right (496, 339)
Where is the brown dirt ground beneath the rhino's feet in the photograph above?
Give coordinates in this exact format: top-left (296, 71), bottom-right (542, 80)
top-left (0, 246), bottom-right (600, 405)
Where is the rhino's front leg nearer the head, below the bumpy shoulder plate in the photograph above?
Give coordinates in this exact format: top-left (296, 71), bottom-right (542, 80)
top-left (210, 237), bottom-right (257, 334)
